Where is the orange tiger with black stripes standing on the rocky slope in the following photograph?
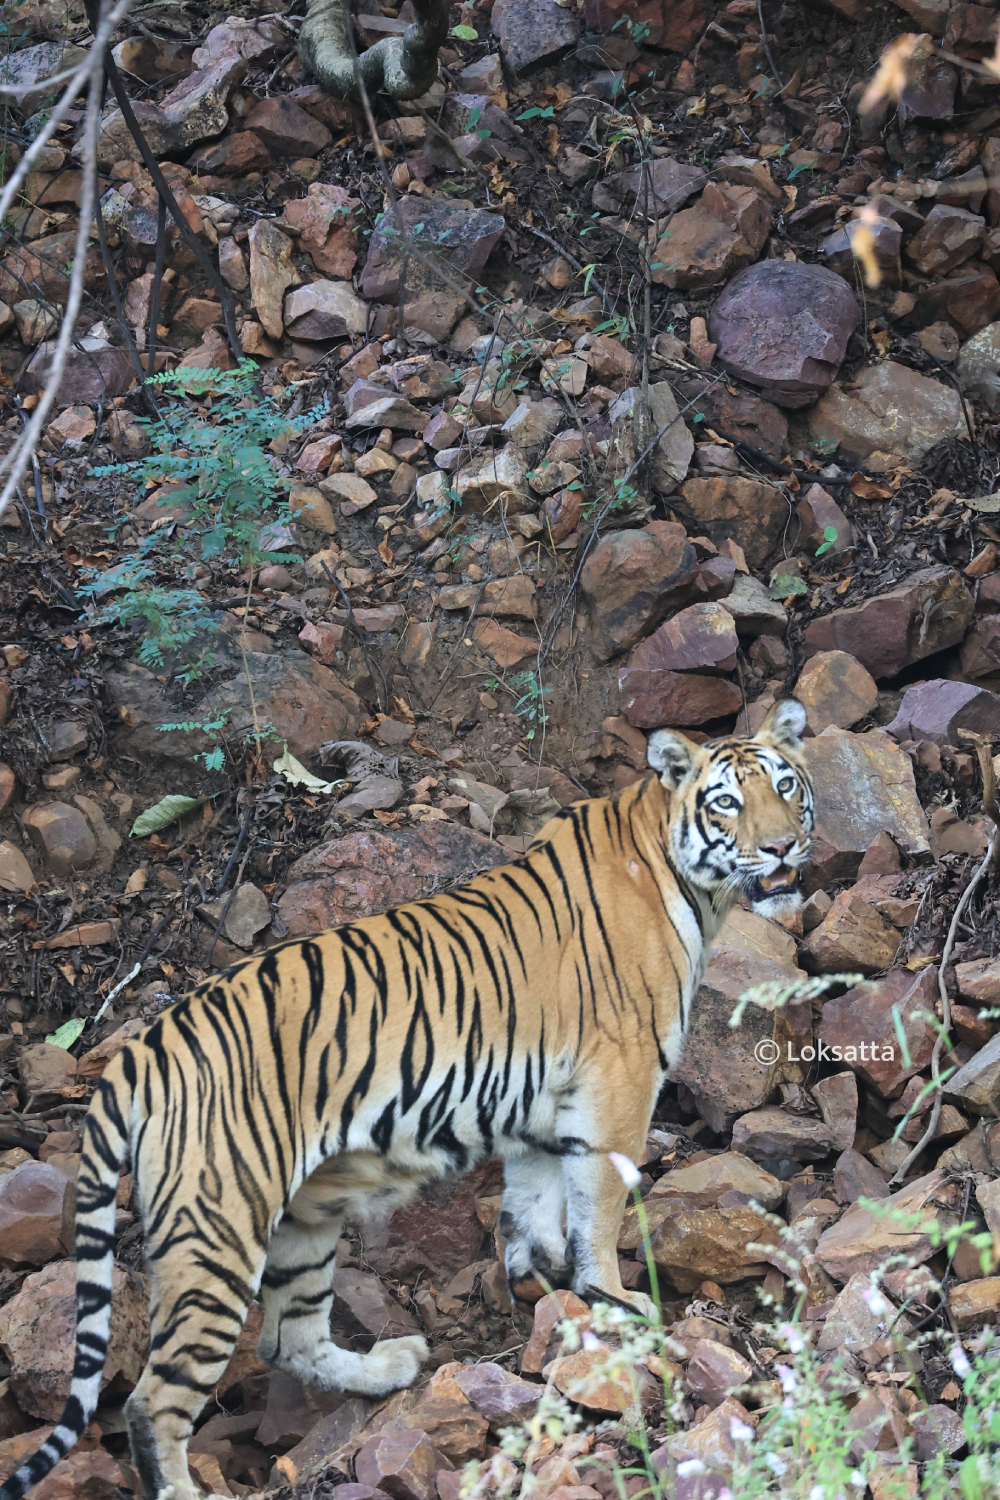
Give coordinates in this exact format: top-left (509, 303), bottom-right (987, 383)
top-left (0, 698), bottom-right (814, 1500)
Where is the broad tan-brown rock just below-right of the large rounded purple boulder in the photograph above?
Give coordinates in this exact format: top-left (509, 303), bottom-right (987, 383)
top-left (810, 360), bottom-right (969, 465)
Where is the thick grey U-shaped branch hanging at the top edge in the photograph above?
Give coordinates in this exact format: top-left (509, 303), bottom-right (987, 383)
top-left (298, 0), bottom-right (448, 99)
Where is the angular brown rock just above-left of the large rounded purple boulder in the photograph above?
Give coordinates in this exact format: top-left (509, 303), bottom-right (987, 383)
top-left (652, 183), bottom-right (771, 291)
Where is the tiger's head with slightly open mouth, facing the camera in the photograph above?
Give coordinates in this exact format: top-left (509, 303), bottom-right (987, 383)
top-left (648, 698), bottom-right (814, 917)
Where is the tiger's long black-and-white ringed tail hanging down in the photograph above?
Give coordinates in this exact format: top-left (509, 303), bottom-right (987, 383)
top-left (0, 1068), bottom-right (132, 1500)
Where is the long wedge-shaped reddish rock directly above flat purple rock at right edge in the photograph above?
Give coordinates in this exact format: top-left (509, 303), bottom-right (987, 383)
top-left (805, 567), bottom-right (975, 678)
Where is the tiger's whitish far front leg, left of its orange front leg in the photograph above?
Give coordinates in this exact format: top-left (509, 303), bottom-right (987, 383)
top-left (499, 1149), bottom-right (573, 1287)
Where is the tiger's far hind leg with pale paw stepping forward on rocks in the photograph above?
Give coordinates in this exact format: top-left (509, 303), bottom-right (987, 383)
top-left (256, 1215), bottom-right (427, 1397)
